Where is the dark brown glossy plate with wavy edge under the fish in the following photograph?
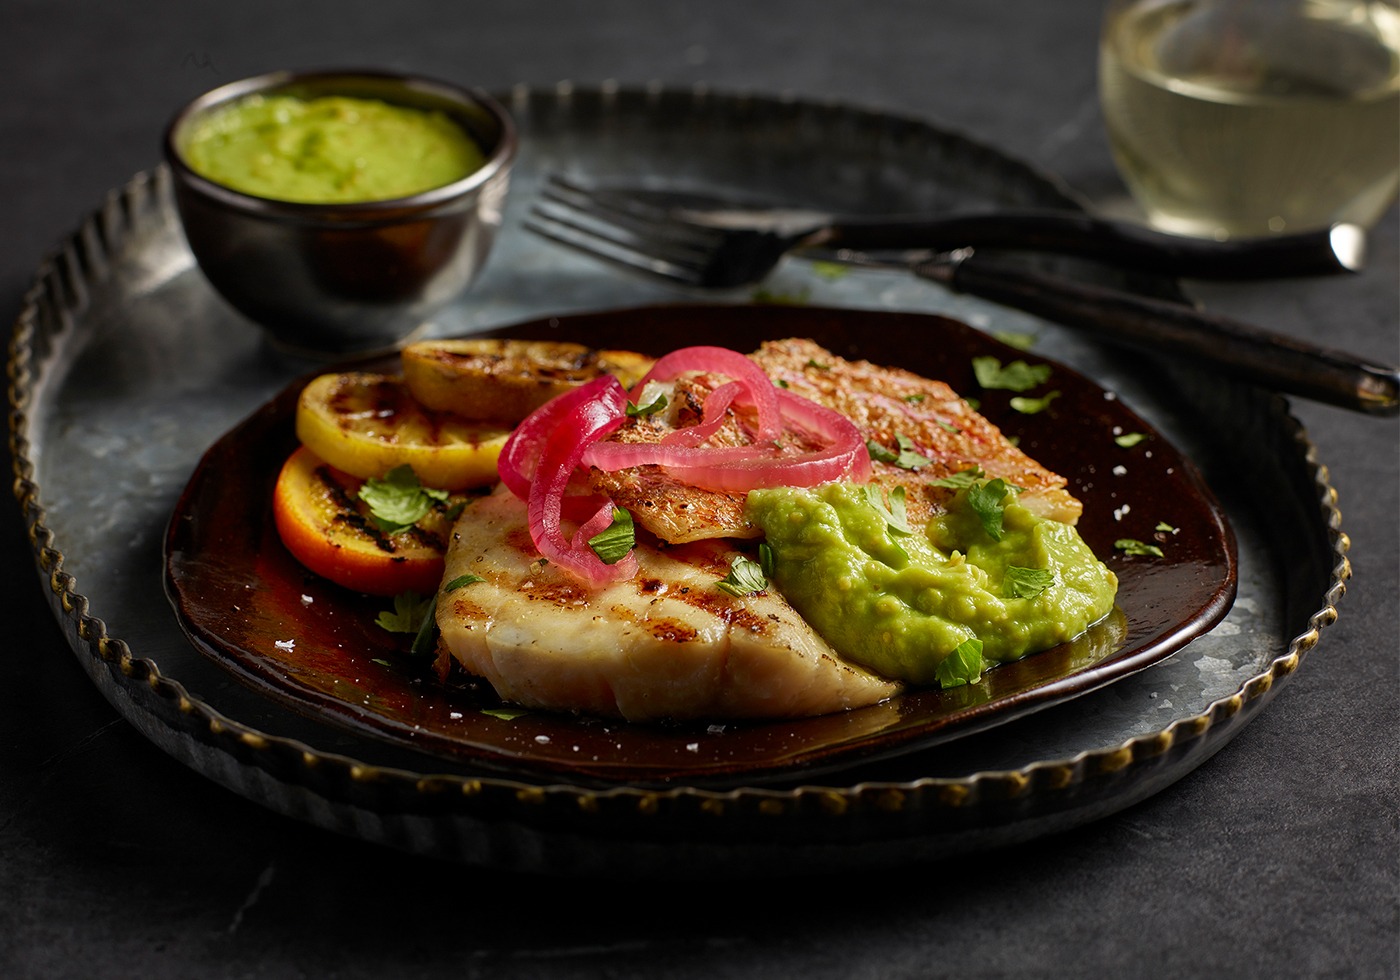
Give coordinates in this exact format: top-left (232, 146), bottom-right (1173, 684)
top-left (165, 305), bottom-right (1238, 787)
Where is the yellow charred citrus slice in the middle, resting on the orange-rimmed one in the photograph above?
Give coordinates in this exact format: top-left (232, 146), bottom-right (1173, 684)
top-left (297, 371), bottom-right (510, 490)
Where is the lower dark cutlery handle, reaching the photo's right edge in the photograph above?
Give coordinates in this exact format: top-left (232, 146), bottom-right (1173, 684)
top-left (913, 253), bottom-right (1400, 416)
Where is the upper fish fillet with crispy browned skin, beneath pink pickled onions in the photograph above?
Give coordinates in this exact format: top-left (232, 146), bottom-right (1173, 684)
top-left (591, 339), bottom-right (1084, 543)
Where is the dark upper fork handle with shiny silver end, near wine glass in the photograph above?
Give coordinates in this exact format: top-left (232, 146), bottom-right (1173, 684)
top-left (804, 210), bottom-right (1366, 280)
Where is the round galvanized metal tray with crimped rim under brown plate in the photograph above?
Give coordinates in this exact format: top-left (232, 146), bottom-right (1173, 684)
top-left (10, 87), bottom-right (1350, 875)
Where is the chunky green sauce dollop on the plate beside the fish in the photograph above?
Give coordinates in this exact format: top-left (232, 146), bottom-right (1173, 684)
top-left (746, 480), bottom-right (1117, 687)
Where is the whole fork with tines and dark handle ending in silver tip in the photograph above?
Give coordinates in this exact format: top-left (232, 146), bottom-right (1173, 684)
top-left (526, 175), bottom-right (1365, 290)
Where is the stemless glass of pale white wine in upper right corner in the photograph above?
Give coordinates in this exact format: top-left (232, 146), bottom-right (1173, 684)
top-left (1099, 0), bottom-right (1400, 238)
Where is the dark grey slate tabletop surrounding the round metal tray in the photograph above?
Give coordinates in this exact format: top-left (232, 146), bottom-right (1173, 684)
top-left (0, 0), bottom-right (1400, 977)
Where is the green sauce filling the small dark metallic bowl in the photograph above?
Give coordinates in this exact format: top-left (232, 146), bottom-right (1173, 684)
top-left (181, 95), bottom-right (486, 204)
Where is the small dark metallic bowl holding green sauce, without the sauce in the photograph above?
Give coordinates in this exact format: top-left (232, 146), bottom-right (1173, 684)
top-left (164, 70), bottom-right (518, 357)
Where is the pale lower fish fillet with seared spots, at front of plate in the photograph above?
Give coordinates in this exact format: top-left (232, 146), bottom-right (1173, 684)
top-left (437, 487), bottom-right (900, 721)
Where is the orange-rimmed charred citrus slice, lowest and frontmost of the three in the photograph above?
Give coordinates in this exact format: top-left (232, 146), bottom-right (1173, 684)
top-left (273, 447), bottom-right (462, 595)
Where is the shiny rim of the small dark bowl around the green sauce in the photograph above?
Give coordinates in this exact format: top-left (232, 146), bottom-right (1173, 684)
top-left (164, 69), bottom-right (519, 221)
